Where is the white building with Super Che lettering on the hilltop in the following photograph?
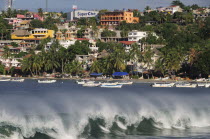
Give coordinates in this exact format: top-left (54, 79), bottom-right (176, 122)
top-left (67, 10), bottom-right (99, 21)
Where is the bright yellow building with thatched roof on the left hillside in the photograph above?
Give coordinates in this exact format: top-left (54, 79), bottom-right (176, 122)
top-left (11, 28), bottom-right (54, 40)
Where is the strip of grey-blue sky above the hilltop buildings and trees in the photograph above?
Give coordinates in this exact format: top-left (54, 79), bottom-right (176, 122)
top-left (0, 0), bottom-right (210, 12)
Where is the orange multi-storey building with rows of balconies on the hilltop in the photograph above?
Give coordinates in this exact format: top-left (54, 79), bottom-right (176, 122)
top-left (101, 11), bottom-right (139, 25)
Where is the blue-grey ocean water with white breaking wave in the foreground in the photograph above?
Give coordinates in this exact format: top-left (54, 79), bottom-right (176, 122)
top-left (0, 80), bottom-right (210, 139)
